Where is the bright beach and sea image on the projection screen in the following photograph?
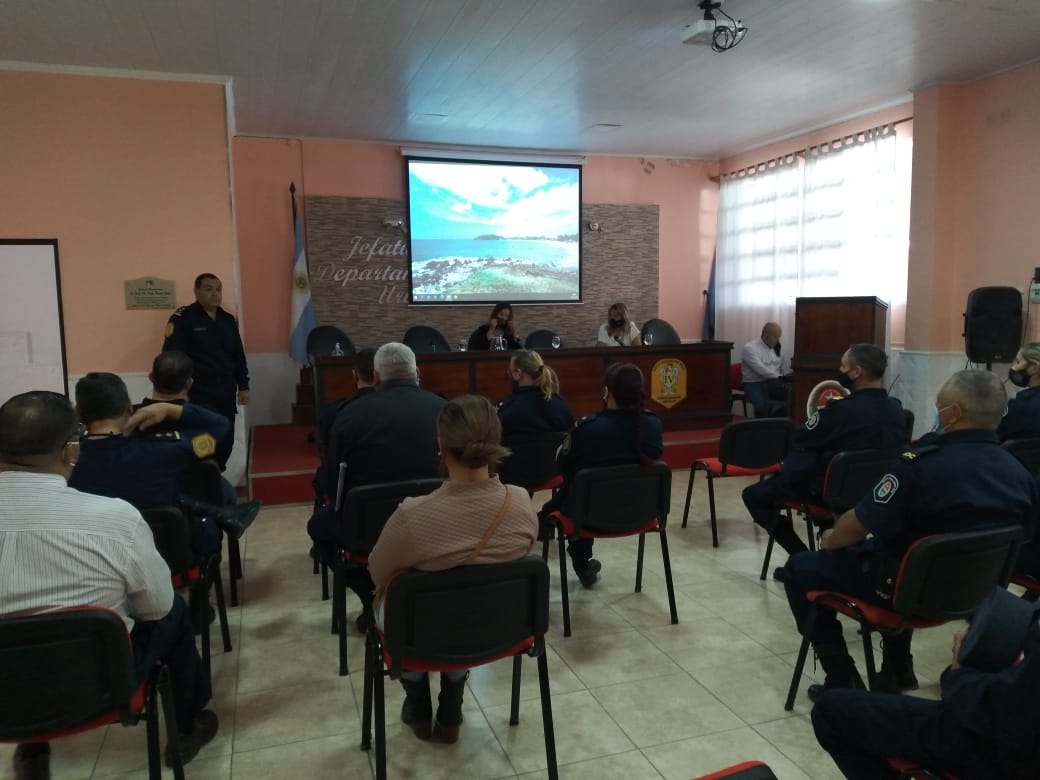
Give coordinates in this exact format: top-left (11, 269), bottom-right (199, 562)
top-left (408, 159), bottom-right (581, 304)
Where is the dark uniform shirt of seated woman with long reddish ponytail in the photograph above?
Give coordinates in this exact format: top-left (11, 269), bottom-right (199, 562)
top-left (543, 409), bottom-right (665, 511)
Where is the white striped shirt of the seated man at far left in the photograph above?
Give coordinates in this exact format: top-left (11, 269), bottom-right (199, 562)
top-left (0, 471), bottom-right (174, 631)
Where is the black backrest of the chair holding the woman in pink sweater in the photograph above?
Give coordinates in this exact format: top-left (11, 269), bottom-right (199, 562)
top-left (383, 555), bottom-right (549, 673)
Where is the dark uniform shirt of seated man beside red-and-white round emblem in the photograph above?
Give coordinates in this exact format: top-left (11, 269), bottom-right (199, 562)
top-left (782, 388), bottom-right (907, 485)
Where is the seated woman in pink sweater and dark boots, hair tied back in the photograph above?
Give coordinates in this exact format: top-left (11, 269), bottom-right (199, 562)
top-left (368, 395), bottom-right (538, 743)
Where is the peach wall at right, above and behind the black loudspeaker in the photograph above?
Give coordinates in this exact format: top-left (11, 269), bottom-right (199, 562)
top-left (907, 64), bottom-right (1040, 350)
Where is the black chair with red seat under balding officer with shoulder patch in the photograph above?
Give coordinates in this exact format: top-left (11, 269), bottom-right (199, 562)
top-left (784, 525), bottom-right (1022, 710)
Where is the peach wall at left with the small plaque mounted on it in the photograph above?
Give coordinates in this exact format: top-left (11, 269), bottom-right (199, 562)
top-left (0, 71), bottom-right (233, 373)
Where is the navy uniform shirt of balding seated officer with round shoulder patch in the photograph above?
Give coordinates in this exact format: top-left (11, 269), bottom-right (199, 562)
top-left (856, 430), bottom-right (1040, 557)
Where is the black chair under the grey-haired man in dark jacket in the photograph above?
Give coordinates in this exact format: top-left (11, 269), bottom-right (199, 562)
top-left (332, 479), bottom-right (444, 676)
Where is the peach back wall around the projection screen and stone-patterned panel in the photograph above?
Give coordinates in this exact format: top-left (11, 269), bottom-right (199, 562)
top-left (232, 136), bottom-right (719, 353)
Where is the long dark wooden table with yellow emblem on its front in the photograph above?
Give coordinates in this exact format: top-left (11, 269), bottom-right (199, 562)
top-left (314, 341), bottom-right (733, 431)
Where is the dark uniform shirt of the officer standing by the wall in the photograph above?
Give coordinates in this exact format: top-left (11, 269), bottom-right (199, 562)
top-left (162, 302), bottom-right (250, 396)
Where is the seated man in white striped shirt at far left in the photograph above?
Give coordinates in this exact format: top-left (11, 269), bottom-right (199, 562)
top-left (0, 391), bottom-right (217, 780)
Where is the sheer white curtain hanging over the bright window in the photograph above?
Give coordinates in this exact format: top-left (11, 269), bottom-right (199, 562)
top-left (716, 126), bottom-right (910, 358)
